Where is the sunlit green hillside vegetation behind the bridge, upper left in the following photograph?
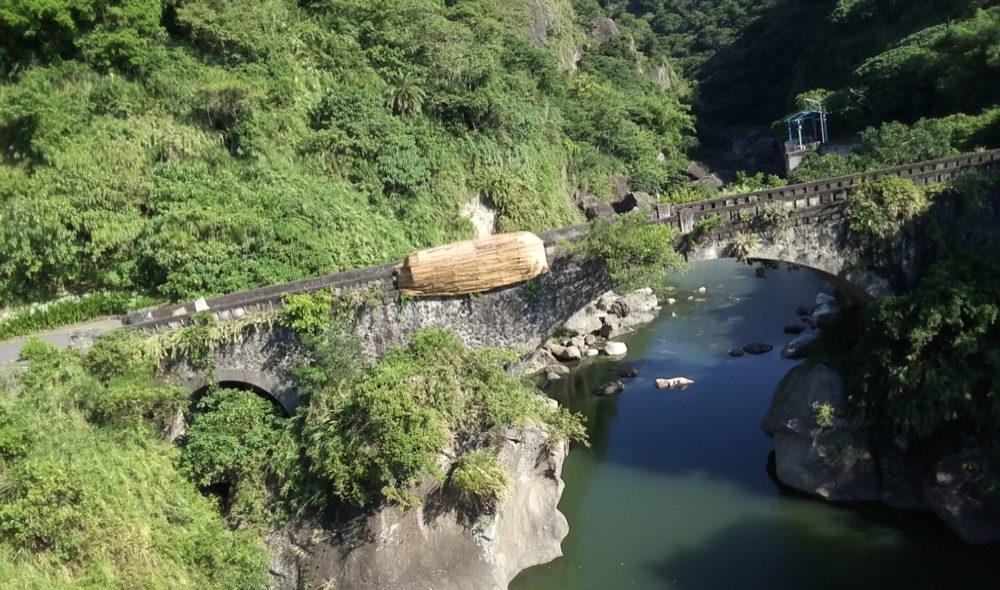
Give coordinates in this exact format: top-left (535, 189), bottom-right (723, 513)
top-left (0, 0), bottom-right (691, 305)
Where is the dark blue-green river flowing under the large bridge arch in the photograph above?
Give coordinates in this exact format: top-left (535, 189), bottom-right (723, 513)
top-left (510, 261), bottom-right (1000, 590)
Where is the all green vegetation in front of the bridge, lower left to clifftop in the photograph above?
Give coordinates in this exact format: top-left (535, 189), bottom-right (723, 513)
top-left (0, 302), bottom-right (584, 589)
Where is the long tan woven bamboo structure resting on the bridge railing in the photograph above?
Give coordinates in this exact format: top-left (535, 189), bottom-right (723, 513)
top-left (396, 232), bottom-right (549, 297)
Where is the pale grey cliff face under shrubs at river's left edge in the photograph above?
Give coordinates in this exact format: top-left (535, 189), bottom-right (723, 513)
top-left (268, 428), bottom-right (569, 590)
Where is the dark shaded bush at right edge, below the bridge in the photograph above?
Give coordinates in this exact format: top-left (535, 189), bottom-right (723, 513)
top-left (850, 253), bottom-right (1000, 437)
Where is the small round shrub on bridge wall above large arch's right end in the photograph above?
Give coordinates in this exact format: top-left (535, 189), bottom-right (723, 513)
top-left (847, 176), bottom-right (928, 240)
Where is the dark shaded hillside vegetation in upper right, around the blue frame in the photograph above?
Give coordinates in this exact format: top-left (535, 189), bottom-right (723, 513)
top-left (604, 0), bottom-right (1000, 171)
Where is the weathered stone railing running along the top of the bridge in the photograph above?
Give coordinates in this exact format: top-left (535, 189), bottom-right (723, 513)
top-left (125, 149), bottom-right (1000, 331)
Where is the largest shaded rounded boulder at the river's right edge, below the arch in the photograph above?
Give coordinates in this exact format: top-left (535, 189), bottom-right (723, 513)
top-left (761, 365), bottom-right (881, 502)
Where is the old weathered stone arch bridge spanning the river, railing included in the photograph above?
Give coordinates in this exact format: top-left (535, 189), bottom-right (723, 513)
top-left (126, 150), bottom-right (1000, 414)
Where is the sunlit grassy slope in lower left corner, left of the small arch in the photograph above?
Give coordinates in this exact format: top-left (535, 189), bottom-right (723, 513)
top-left (0, 341), bottom-right (267, 590)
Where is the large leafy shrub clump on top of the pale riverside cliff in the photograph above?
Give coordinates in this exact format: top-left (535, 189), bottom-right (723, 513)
top-left (301, 329), bottom-right (585, 506)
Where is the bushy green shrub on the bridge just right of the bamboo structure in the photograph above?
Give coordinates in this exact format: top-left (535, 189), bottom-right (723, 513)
top-left (571, 213), bottom-right (684, 291)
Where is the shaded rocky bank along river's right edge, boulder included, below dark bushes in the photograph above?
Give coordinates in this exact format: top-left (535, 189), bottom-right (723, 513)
top-left (762, 363), bottom-right (1000, 544)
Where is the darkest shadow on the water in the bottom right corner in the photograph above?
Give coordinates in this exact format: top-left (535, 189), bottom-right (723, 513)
top-left (649, 514), bottom-right (1000, 590)
